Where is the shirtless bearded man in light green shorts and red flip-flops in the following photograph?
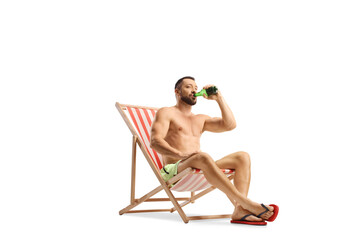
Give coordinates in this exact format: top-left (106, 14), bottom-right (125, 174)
top-left (150, 77), bottom-right (278, 224)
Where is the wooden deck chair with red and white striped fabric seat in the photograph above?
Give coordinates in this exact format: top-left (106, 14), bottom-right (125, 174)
top-left (115, 102), bottom-right (234, 223)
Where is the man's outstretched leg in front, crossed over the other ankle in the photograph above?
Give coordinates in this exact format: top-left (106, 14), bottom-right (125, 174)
top-left (178, 152), bottom-right (274, 220)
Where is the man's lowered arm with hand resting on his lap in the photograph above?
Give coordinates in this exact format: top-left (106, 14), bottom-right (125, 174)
top-left (150, 108), bottom-right (182, 159)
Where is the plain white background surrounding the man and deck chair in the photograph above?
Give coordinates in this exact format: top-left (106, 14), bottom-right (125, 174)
top-left (0, 0), bottom-right (360, 239)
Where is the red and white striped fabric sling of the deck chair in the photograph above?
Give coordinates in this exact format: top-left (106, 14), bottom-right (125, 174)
top-left (124, 107), bottom-right (234, 192)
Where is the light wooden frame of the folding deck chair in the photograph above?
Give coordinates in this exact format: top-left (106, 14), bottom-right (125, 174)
top-left (115, 102), bottom-right (234, 223)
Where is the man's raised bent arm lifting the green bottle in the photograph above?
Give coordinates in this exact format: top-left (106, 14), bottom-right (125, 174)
top-left (203, 88), bottom-right (236, 132)
